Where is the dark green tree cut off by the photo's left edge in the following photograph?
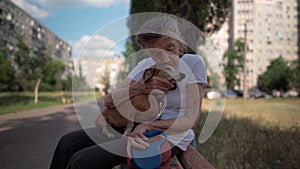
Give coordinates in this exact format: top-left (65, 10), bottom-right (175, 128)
top-left (0, 49), bottom-right (15, 91)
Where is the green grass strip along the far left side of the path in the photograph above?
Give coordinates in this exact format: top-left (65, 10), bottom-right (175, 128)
top-left (0, 92), bottom-right (101, 115)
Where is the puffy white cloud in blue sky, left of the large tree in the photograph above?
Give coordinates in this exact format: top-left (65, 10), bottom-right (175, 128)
top-left (69, 35), bottom-right (118, 58)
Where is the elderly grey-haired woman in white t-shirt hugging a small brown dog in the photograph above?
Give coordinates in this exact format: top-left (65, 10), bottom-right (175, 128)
top-left (50, 16), bottom-right (207, 169)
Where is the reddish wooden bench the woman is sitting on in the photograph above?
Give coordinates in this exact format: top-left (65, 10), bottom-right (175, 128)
top-left (122, 145), bottom-right (214, 169)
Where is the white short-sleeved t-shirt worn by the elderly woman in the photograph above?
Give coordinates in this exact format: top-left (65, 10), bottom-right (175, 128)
top-left (128, 54), bottom-right (207, 151)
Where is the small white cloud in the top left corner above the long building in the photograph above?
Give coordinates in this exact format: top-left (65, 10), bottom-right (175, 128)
top-left (12, 0), bottom-right (50, 18)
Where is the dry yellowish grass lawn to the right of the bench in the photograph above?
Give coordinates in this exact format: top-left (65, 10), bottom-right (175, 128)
top-left (196, 98), bottom-right (300, 169)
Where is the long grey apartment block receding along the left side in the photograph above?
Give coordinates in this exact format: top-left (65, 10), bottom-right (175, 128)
top-left (0, 0), bottom-right (72, 76)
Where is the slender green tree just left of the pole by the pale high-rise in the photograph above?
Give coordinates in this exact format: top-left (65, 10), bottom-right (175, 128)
top-left (223, 39), bottom-right (245, 89)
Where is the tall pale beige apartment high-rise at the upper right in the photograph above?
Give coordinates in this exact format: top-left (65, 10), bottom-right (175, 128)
top-left (230, 0), bottom-right (299, 87)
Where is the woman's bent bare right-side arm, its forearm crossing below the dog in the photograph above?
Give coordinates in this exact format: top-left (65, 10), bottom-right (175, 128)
top-left (132, 84), bottom-right (203, 138)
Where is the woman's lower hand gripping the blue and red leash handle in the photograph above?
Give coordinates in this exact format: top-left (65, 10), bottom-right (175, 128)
top-left (127, 123), bottom-right (151, 158)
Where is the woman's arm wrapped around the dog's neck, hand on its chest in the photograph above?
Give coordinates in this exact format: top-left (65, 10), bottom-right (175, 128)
top-left (104, 76), bottom-right (173, 108)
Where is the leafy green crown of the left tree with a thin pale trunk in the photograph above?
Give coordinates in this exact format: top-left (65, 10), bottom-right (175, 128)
top-left (14, 36), bottom-right (65, 91)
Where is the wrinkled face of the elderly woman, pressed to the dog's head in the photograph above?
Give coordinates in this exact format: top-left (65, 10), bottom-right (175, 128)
top-left (147, 36), bottom-right (180, 68)
